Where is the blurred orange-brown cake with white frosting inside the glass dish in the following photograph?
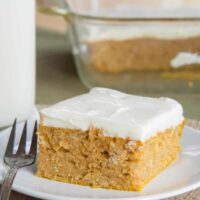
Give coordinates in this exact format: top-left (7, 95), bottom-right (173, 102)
top-left (86, 22), bottom-right (200, 73)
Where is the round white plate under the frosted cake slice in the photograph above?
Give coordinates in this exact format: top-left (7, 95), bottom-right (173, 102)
top-left (0, 123), bottom-right (200, 200)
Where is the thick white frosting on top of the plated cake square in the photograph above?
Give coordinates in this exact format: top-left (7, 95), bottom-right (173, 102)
top-left (41, 88), bottom-right (183, 141)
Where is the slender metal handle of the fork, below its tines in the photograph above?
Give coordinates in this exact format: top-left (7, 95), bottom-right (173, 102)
top-left (0, 166), bottom-right (18, 200)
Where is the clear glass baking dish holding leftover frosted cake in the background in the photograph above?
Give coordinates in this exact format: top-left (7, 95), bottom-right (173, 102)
top-left (37, 0), bottom-right (200, 93)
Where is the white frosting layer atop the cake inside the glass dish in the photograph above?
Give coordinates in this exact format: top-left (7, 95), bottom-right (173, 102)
top-left (85, 22), bottom-right (200, 42)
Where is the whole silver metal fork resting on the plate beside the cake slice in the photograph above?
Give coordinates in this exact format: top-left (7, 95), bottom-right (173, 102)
top-left (0, 119), bottom-right (37, 200)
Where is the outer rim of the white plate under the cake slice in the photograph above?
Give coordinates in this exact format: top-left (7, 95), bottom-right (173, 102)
top-left (0, 120), bottom-right (200, 200)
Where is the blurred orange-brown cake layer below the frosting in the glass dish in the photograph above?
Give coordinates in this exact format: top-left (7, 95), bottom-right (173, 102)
top-left (86, 36), bottom-right (200, 74)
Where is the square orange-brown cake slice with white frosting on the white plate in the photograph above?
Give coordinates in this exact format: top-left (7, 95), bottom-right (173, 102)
top-left (37, 88), bottom-right (184, 191)
